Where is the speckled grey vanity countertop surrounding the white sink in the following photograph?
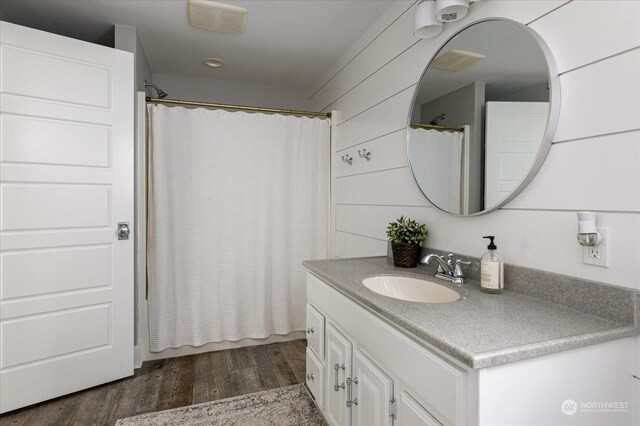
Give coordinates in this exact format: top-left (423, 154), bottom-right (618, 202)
top-left (303, 257), bottom-right (639, 368)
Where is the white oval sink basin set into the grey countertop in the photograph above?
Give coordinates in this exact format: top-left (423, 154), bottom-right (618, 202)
top-left (362, 275), bottom-right (460, 303)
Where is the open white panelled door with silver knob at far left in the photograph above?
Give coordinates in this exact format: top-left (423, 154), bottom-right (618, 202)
top-left (0, 22), bottom-right (133, 412)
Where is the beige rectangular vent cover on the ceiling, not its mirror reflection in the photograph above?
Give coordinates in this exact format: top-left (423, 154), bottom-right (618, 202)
top-left (189, 0), bottom-right (247, 34)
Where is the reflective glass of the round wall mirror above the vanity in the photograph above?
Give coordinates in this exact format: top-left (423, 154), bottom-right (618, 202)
top-left (407, 20), bottom-right (560, 215)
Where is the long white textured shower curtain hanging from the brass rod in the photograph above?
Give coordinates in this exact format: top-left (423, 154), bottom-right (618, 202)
top-left (148, 105), bottom-right (330, 352)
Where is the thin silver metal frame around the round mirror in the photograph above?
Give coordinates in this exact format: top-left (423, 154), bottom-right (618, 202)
top-left (406, 18), bottom-right (560, 217)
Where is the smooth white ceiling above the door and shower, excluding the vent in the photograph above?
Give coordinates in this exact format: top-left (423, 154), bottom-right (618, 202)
top-left (0, 0), bottom-right (393, 88)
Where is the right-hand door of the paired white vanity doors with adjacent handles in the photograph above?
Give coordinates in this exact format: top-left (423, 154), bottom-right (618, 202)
top-left (352, 351), bottom-right (393, 426)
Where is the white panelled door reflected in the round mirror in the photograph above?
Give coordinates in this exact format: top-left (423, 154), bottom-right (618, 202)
top-left (484, 102), bottom-right (549, 207)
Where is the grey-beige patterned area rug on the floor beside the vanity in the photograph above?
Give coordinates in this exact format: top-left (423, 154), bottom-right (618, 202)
top-left (116, 384), bottom-right (326, 426)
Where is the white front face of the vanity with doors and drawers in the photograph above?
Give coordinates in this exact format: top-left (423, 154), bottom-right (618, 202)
top-left (307, 274), bottom-right (466, 426)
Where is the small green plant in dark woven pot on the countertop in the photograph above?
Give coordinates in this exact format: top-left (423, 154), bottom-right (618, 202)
top-left (387, 216), bottom-right (427, 268)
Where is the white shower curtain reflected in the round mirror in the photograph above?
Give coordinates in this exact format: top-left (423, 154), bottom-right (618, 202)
top-left (409, 129), bottom-right (464, 213)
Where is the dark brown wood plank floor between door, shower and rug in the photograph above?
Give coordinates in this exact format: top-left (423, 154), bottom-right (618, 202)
top-left (0, 340), bottom-right (306, 426)
